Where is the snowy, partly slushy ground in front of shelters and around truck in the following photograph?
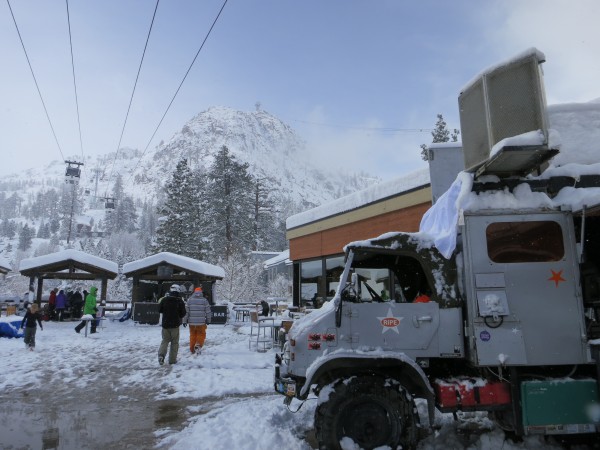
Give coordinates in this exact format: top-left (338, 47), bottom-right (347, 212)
top-left (0, 316), bottom-right (585, 450)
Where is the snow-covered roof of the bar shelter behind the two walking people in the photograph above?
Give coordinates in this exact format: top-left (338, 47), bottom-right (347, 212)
top-left (123, 252), bottom-right (225, 279)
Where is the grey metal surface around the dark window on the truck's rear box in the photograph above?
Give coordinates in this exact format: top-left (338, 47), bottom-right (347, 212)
top-left (465, 212), bottom-right (587, 365)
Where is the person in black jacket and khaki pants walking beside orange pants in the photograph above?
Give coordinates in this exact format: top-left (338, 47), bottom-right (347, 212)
top-left (158, 284), bottom-right (185, 366)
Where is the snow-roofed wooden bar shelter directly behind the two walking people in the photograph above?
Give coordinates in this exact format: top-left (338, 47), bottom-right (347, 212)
top-left (123, 252), bottom-right (225, 303)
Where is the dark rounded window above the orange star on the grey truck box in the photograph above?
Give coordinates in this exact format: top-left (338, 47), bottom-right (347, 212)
top-left (486, 221), bottom-right (565, 264)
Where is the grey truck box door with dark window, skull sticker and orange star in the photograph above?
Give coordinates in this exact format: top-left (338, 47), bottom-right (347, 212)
top-left (464, 212), bottom-right (586, 365)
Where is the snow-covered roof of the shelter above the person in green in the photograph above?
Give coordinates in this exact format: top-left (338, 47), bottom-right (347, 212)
top-left (19, 249), bottom-right (119, 279)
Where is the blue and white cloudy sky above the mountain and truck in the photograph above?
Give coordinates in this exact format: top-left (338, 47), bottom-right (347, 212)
top-left (0, 0), bottom-right (600, 179)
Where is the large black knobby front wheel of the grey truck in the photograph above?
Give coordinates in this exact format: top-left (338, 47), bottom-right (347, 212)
top-left (315, 376), bottom-right (419, 449)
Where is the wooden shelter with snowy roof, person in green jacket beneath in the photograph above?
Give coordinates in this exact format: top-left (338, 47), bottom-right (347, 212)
top-left (19, 250), bottom-right (119, 303)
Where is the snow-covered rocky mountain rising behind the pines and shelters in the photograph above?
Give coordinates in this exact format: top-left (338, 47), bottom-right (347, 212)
top-left (0, 107), bottom-right (379, 293)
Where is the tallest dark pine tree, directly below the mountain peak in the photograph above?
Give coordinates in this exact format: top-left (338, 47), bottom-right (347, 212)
top-left (202, 146), bottom-right (254, 260)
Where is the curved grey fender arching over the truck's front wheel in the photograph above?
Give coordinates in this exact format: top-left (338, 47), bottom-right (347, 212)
top-left (298, 349), bottom-right (435, 426)
